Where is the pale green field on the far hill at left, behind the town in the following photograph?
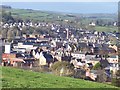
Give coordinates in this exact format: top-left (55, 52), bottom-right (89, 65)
top-left (5, 9), bottom-right (67, 21)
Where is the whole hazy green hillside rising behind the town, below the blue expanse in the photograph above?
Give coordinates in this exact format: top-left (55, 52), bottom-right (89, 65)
top-left (0, 5), bottom-right (118, 32)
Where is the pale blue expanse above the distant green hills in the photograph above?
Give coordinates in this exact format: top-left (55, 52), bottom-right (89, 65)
top-left (2, 0), bottom-right (118, 13)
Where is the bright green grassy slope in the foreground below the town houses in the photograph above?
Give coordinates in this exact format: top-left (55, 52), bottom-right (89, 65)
top-left (0, 67), bottom-right (119, 88)
